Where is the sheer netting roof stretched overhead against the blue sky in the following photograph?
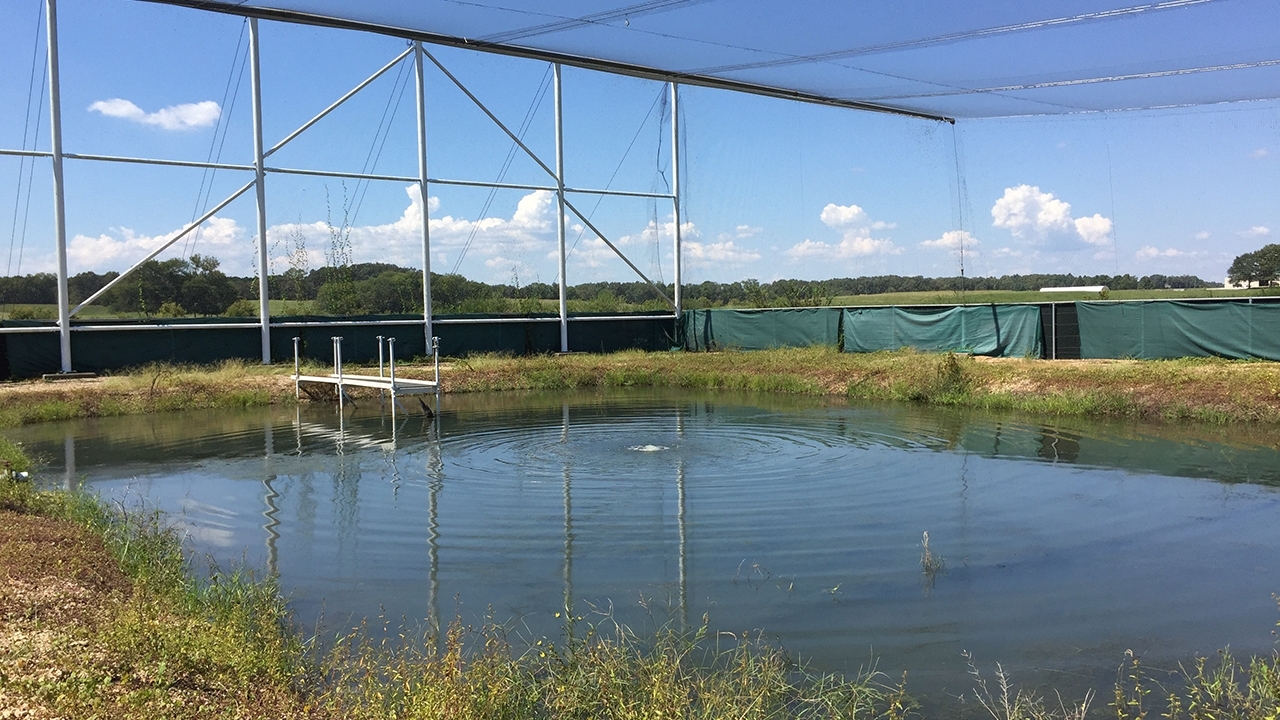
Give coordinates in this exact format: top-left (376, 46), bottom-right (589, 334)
top-left (142, 0), bottom-right (1280, 118)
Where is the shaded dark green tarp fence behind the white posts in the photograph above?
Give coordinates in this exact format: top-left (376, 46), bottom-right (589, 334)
top-left (0, 313), bottom-right (676, 379)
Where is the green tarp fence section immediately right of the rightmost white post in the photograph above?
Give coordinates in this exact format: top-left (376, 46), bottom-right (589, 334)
top-left (681, 307), bottom-right (840, 350)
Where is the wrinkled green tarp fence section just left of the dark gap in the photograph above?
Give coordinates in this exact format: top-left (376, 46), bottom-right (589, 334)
top-left (844, 305), bottom-right (1042, 357)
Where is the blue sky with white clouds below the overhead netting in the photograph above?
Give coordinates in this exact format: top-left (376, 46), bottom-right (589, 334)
top-left (0, 0), bottom-right (1280, 283)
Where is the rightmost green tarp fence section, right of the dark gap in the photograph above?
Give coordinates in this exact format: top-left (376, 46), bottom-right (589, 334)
top-left (1075, 301), bottom-right (1280, 360)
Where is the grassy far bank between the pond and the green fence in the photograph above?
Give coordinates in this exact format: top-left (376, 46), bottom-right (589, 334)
top-left (0, 347), bottom-right (1280, 428)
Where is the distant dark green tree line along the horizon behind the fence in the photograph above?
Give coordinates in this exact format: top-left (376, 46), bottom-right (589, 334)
top-left (0, 256), bottom-right (1213, 316)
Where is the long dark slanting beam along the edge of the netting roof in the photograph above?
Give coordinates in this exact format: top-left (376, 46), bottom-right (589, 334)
top-left (143, 0), bottom-right (955, 123)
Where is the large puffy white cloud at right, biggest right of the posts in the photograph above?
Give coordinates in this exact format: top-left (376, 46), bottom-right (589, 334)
top-left (991, 184), bottom-right (1112, 249)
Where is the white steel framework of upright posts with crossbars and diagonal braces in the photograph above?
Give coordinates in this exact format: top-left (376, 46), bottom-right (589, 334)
top-left (0, 0), bottom-right (682, 373)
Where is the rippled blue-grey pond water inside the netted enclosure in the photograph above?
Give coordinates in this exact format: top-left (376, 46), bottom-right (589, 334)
top-left (13, 391), bottom-right (1280, 701)
